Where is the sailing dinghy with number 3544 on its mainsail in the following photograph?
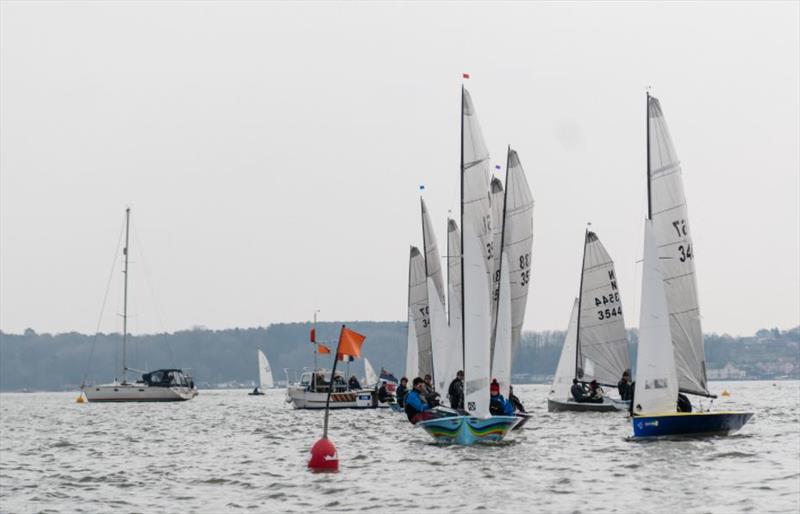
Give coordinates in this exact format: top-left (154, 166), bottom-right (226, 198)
top-left (547, 229), bottom-right (630, 412)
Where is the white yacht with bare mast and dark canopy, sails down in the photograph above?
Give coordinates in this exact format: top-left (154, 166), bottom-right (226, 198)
top-left (81, 207), bottom-right (197, 402)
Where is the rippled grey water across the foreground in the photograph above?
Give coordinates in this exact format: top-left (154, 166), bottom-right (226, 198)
top-left (0, 382), bottom-right (800, 513)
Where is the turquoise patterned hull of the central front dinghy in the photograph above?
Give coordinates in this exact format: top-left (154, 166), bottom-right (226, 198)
top-left (416, 416), bottom-right (520, 446)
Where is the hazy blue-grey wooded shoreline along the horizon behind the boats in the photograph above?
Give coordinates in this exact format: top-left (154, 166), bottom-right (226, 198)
top-left (0, 321), bottom-right (800, 391)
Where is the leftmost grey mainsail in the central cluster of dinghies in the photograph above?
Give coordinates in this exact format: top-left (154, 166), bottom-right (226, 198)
top-left (408, 246), bottom-right (433, 376)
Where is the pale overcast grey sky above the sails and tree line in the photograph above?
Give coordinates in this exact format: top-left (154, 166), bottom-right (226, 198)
top-left (0, 1), bottom-right (800, 334)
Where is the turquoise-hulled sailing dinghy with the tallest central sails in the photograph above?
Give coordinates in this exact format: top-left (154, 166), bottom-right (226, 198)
top-left (416, 86), bottom-right (519, 445)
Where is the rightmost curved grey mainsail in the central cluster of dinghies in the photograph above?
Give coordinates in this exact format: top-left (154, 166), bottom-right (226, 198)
top-left (503, 148), bottom-right (533, 358)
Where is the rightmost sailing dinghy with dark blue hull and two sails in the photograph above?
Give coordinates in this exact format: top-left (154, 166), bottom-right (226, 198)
top-left (631, 94), bottom-right (753, 438)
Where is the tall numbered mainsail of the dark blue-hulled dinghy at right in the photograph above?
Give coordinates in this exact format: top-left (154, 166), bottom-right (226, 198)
top-left (647, 95), bottom-right (708, 395)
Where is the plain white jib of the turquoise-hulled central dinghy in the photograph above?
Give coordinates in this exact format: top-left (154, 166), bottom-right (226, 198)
top-left (462, 222), bottom-right (491, 418)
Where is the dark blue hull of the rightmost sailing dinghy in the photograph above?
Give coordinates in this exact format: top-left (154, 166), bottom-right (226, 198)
top-left (631, 412), bottom-right (753, 439)
